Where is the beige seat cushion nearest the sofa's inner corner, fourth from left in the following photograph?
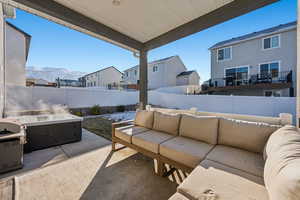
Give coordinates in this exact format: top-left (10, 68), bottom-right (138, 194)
top-left (206, 145), bottom-right (264, 177)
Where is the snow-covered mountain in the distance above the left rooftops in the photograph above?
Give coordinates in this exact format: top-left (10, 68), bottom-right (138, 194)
top-left (26, 67), bottom-right (86, 82)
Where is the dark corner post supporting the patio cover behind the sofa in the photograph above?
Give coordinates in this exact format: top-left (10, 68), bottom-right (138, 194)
top-left (139, 50), bottom-right (148, 110)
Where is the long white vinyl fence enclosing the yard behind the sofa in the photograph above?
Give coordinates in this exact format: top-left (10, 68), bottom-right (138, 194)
top-left (6, 87), bottom-right (296, 122)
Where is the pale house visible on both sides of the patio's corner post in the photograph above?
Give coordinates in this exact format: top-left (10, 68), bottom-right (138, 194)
top-left (123, 56), bottom-right (199, 89)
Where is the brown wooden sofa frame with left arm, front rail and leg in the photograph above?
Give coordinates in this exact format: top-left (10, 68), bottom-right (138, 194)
top-left (112, 120), bottom-right (193, 176)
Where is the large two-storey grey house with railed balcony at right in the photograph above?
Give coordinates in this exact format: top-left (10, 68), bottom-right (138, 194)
top-left (202, 22), bottom-right (297, 96)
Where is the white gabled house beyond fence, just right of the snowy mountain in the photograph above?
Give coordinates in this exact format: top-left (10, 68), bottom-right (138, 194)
top-left (80, 66), bottom-right (123, 87)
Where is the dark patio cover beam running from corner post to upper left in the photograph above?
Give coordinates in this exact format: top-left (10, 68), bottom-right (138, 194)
top-left (7, 0), bottom-right (143, 51)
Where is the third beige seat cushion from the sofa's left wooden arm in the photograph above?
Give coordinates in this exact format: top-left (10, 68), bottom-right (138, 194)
top-left (159, 136), bottom-right (213, 168)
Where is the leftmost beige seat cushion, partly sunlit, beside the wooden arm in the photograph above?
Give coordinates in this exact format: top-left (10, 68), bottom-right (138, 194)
top-left (115, 125), bottom-right (149, 143)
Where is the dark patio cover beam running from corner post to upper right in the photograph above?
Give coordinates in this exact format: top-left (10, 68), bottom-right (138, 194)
top-left (144, 0), bottom-right (278, 50)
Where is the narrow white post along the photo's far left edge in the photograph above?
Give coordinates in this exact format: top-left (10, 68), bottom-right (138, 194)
top-left (0, 3), bottom-right (5, 118)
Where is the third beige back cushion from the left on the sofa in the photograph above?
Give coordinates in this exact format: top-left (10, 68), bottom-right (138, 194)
top-left (179, 115), bottom-right (219, 144)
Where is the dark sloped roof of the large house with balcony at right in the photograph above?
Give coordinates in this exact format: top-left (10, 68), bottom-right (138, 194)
top-left (209, 21), bottom-right (297, 49)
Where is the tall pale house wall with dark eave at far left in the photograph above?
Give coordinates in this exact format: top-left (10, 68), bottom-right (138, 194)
top-left (5, 22), bottom-right (31, 86)
